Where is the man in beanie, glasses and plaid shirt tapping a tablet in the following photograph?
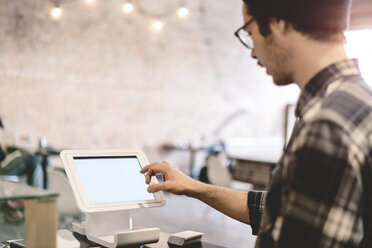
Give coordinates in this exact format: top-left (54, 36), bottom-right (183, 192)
top-left (141, 0), bottom-right (372, 248)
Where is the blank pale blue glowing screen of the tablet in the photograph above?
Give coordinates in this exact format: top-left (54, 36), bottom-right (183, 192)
top-left (74, 156), bottom-right (155, 205)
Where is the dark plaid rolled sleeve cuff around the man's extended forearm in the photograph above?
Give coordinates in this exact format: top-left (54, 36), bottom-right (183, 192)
top-left (248, 190), bottom-right (266, 235)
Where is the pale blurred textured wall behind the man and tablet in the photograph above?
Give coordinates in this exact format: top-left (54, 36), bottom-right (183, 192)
top-left (0, 0), bottom-right (298, 158)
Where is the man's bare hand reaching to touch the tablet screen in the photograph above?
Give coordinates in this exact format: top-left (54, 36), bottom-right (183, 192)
top-left (141, 161), bottom-right (200, 195)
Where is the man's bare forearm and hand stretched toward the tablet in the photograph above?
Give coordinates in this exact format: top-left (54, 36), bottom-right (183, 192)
top-left (141, 161), bottom-right (250, 224)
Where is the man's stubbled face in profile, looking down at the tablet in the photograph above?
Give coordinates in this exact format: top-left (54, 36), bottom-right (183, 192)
top-left (243, 3), bottom-right (293, 85)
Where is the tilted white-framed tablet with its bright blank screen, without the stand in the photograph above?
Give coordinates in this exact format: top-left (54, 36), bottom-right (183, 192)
top-left (60, 150), bottom-right (165, 213)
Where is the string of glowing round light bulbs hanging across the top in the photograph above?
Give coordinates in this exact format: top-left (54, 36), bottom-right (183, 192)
top-left (50, 0), bottom-right (190, 32)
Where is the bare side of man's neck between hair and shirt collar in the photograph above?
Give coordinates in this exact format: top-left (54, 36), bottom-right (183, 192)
top-left (293, 37), bottom-right (347, 89)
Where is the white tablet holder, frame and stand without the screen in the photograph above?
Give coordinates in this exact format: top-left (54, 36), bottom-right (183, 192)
top-left (61, 150), bottom-right (165, 248)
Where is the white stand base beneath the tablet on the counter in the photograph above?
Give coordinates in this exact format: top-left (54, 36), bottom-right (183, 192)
top-left (74, 210), bottom-right (160, 248)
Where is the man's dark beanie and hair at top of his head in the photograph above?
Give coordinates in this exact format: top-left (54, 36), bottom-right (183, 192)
top-left (243, 0), bottom-right (351, 41)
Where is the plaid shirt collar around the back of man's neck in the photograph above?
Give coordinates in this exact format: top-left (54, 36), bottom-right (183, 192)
top-left (295, 59), bottom-right (360, 118)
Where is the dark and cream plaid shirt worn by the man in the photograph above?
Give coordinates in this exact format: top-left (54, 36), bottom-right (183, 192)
top-left (248, 60), bottom-right (372, 248)
